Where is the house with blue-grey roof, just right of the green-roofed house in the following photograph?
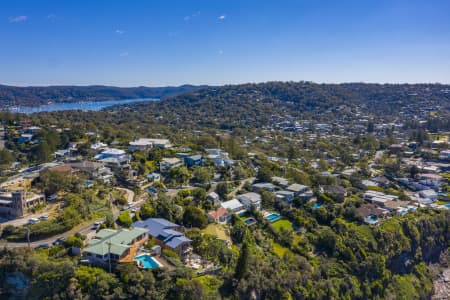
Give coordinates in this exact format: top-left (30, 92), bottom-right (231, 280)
top-left (133, 218), bottom-right (192, 258)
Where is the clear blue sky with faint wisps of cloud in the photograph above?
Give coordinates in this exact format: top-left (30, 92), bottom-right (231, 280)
top-left (0, 0), bottom-right (450, 86)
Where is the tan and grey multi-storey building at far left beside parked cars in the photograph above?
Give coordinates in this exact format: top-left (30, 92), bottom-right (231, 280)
top-left (0, 190), bottom-right (45, 218)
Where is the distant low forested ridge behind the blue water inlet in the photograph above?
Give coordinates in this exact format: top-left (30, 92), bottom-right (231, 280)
top-left (0, 85), bottom-right (206, 108)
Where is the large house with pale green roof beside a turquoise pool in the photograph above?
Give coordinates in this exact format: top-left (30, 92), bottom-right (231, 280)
top-left (83, 228), bottom-right (148, 264)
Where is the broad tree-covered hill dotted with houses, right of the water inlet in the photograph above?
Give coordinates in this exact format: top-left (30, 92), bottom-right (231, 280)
top-left (111, 82), bottom-right (450, 129)
